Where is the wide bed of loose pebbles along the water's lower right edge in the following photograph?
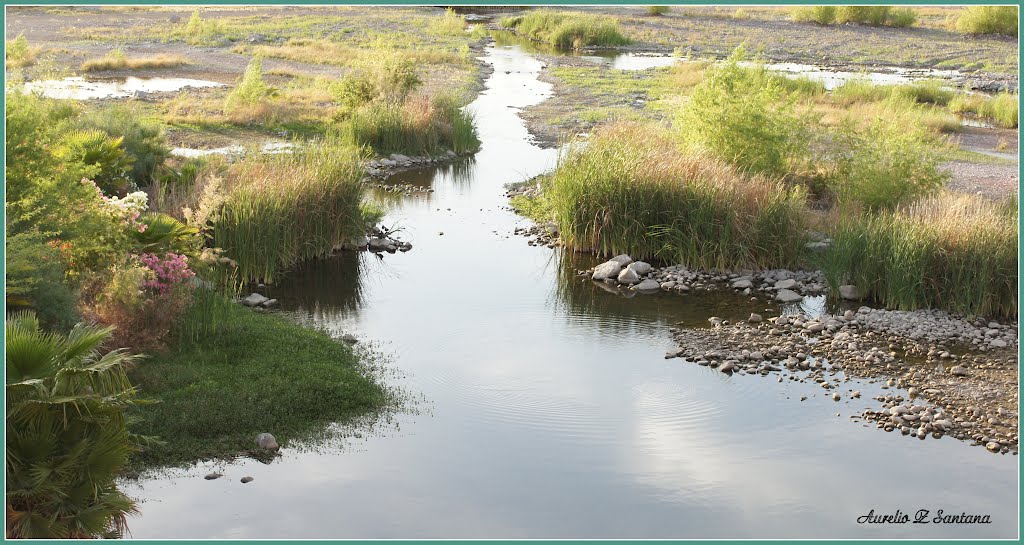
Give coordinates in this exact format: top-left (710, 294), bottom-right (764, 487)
top-left (666, 306), bottom-right (1018, 453)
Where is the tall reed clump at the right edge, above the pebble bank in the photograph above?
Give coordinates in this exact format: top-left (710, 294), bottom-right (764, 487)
top-left (822, 194), bottom-right (1018, 319)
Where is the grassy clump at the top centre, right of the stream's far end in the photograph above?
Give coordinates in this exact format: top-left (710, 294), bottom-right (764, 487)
top-left (502, 9), bottom-right (630, 49)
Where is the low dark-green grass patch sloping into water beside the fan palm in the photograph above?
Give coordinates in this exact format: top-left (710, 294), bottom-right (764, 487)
top-left (124, 305), bottom-right (388, 469)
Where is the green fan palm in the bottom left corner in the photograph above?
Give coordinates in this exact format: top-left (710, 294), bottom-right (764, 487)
top-left (5, 312), bottom-right (144, 539)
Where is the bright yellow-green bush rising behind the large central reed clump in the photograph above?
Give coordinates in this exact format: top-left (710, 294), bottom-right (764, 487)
top-left (678, 47), bottom-right (808, 176)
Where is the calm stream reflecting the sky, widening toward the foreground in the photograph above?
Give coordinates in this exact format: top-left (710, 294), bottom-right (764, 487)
top-left (124, 46), bottom-right (1018, 538)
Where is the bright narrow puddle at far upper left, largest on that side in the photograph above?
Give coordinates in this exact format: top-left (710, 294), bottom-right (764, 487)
top-left (23, 77), bottom-right (224, 100)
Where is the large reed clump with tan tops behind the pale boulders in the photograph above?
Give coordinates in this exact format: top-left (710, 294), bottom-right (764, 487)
top-left (538, 124), bottom-right (804, 268)
